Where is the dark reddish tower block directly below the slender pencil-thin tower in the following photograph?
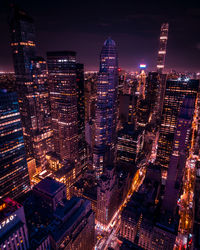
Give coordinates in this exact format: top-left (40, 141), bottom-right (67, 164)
top-left (146, 72), bottom-right (166, 121)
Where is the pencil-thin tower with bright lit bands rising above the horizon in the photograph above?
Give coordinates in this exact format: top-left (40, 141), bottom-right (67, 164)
top-left (157, 23), bottom-right (169, 73)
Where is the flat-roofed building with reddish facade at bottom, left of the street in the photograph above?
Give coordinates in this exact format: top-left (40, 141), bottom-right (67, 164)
top-left (48, 197), bottom-right (95, 250)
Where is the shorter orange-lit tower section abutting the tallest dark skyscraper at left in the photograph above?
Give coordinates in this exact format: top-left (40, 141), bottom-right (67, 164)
top-left (31, 57), bottom-right (52, 169)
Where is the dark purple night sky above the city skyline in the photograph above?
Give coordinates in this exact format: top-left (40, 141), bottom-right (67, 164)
top-left (0, 0), bottom-right (200, 71)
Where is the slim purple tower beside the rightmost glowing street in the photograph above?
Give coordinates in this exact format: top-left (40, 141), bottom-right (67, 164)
top-left (163, 96), bottom-right (195, 213)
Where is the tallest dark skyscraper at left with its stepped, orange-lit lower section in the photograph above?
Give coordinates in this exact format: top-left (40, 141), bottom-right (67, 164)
top-left (10, 6), bottom-right (52, 168)
